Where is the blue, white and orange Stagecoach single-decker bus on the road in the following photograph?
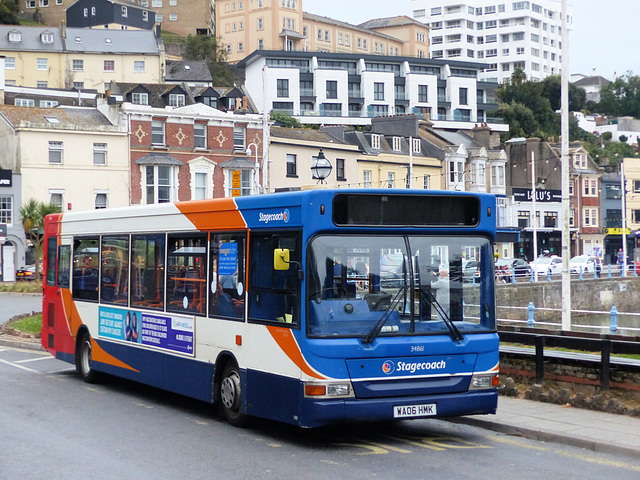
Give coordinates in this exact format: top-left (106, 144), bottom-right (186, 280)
top-left (42, 189), bottom-right (499, 428)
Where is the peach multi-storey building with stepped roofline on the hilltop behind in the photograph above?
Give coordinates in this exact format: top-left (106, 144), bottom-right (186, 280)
top-left (216, 0), bottom-right (428, 63)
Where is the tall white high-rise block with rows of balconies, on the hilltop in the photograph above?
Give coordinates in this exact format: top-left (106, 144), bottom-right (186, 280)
top-left (412, 0), bottom-right (572, 83)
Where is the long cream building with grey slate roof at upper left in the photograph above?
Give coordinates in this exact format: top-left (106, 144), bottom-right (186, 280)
top-left (0, 25), bottom-right (165, 93)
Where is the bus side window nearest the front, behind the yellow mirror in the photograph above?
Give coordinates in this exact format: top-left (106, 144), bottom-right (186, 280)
top-left (249, 232), bottom-right (301, 325)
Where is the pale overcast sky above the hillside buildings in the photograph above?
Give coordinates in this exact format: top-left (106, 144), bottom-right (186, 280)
top-left (302, 0), bottom-right (640, 80)
